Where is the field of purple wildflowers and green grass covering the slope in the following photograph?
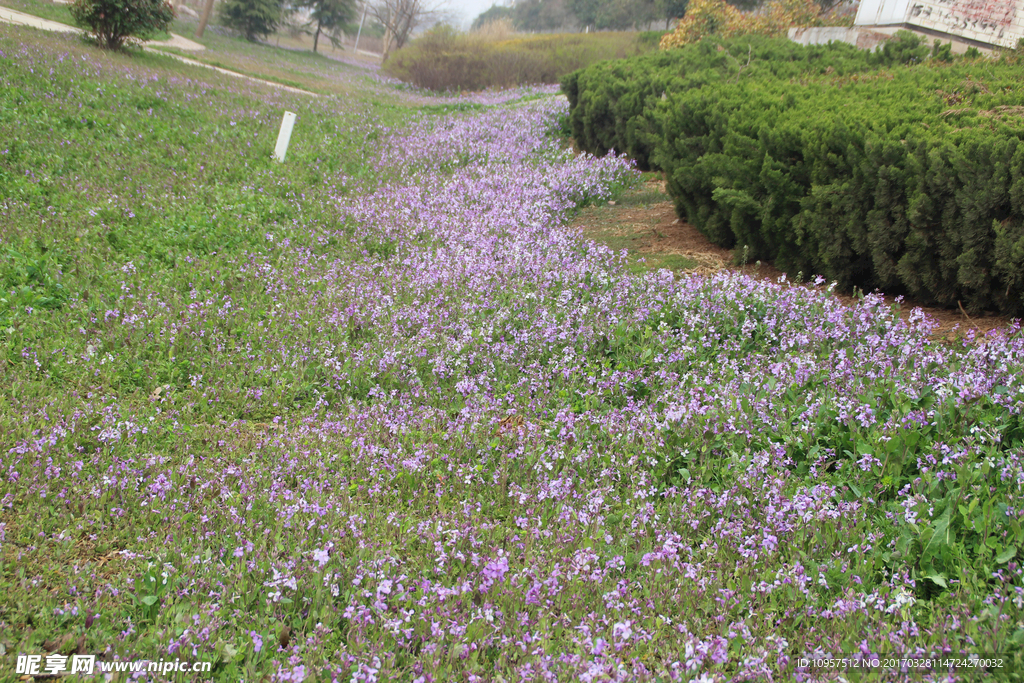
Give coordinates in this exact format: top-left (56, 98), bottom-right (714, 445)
top-left (0, 28), bottom-right (1024, 683)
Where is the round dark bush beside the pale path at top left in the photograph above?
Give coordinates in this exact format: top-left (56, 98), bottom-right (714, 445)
top-left (70, 0), bottom-right (174, 50)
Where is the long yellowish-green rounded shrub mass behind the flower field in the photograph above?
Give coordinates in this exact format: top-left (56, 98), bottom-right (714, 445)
top-left (384, 26), bottom-right (655, 91)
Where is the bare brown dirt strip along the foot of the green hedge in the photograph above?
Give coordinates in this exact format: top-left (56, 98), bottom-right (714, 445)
top-left (573, 180), bottom-right (1013, 341)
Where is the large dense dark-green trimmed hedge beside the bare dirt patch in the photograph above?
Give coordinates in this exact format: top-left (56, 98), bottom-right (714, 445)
top-left (564, 39), bottom-right (1024, 314)
